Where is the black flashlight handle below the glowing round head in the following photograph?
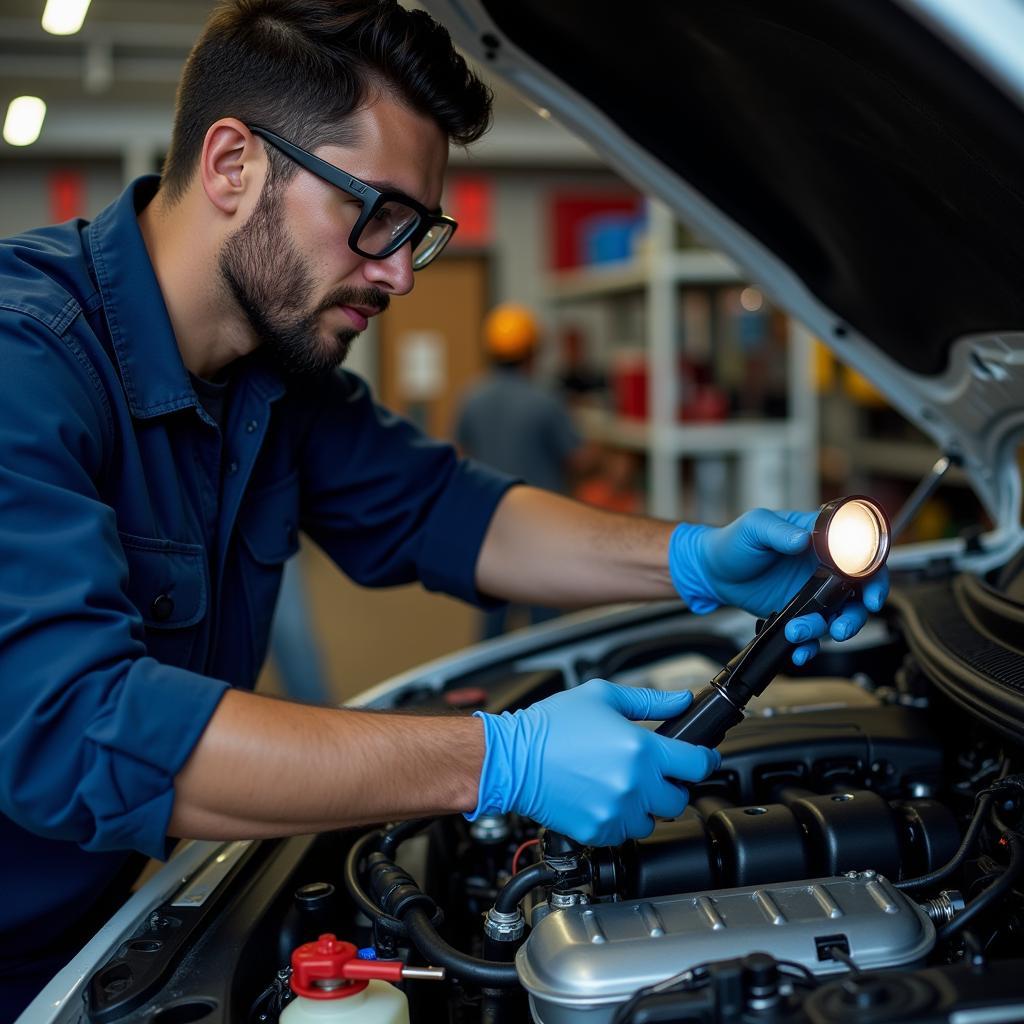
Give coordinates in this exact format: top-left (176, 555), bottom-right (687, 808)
top-left (657, 568), bottom-right (857, 746)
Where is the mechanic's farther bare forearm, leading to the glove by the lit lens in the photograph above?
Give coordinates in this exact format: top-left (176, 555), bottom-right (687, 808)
top-left (476, 486), bottom-right (676, 607)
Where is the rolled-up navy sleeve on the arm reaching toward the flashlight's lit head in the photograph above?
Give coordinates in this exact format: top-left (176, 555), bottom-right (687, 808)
top-left (301, 373), bottom-right (517, 604)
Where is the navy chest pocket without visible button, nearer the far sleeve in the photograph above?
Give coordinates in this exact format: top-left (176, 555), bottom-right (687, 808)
top-left (238, 473), bottom-right (299, 668)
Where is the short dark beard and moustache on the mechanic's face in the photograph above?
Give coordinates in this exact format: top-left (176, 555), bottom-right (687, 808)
top-left (217, 181), bottom-right (389, 377)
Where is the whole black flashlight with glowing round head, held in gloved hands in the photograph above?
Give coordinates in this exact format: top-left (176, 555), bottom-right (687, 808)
top-left (657, 495), bottom-right (891, 746)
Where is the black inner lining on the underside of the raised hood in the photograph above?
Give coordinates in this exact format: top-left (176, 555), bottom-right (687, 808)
top-left (483, 0), bottom-right (1024, 375)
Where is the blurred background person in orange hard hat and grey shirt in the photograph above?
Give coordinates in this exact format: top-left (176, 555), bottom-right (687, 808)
top-left (455, 302), bottom-right (588, 640)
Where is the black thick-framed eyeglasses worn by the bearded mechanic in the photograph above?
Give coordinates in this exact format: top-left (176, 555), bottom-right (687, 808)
top-left (249, 125), bottom-right (459, 270)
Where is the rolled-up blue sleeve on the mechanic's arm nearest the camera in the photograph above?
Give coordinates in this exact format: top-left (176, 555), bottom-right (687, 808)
top-left (0, 310), bottom-right (227, 857)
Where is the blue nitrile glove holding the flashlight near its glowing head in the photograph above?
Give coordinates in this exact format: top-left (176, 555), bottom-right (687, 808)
top-left (669, 509), bottom-right (889, 665)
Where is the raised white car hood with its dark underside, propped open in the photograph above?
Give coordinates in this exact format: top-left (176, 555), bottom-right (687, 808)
top-left (426, 0), bottom-right (1024, 567)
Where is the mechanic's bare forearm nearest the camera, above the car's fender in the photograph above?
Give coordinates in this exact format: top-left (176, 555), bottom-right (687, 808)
top-left (168, 690), bottom-right (483, 839)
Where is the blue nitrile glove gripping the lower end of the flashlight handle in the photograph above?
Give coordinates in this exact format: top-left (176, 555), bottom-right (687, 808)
top-left (466, 679), bottom-right (721, 846)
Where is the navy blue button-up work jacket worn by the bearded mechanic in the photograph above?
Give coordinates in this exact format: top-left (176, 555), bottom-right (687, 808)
top-left (0, 177), bottom-right (511, 1016)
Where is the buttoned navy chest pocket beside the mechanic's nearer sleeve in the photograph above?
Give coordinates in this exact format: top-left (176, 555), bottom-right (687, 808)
top-left (120, 532), bottom-right (209, 668)
